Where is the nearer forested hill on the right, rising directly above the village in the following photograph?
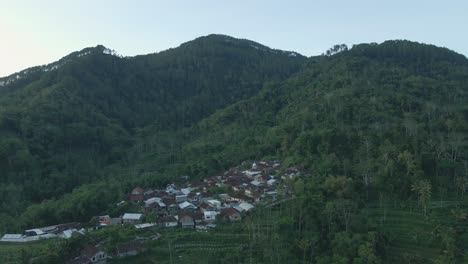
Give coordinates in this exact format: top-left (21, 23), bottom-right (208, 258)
top-left (176, 38), bottom-right (468, 195)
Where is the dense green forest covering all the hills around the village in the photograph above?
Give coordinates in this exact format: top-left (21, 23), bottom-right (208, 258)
top-left (0, 35), bottom-right (468, 264)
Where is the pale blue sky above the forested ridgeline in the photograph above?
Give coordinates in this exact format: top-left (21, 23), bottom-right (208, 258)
top-left (0, 0), bottom-right (468, 76)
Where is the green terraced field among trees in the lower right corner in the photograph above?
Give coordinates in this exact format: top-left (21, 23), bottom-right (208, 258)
top-left (367, 201), bottom-right (468, 263)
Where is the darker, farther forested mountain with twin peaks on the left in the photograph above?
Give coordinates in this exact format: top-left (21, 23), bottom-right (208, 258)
top-left (0, 35), bottom-right (306, 208)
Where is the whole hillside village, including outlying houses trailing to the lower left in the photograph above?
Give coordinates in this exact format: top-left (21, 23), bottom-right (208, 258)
top-left (0, 161), bottom-right (302, 264)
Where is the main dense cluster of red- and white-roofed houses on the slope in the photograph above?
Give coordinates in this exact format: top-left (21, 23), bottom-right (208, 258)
top-left (112, 161), bottom-right (301, 229)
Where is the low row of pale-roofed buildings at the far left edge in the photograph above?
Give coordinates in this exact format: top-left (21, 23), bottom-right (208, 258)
top-left (0, 223), bottom-right (84, 243)
